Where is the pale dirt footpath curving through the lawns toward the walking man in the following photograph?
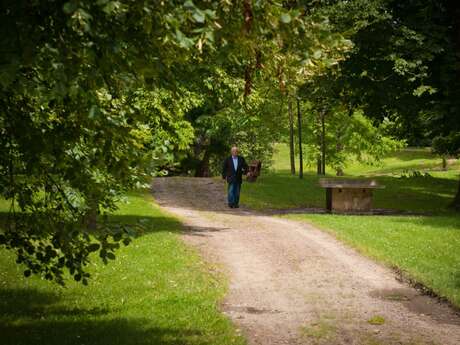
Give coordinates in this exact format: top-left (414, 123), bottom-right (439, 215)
top-left (153, 177), bottom-right (460, 345)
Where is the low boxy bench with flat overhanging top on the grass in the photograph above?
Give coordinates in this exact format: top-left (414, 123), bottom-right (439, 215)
top-left (319, 178), bottom-right (385, 212)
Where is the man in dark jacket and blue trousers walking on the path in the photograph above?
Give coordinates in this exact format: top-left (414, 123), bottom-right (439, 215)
top-left (222, 146), bottom-right (248, 208)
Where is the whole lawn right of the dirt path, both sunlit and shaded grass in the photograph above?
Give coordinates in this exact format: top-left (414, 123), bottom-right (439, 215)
top-left (242, 144), bottom-right (460, 307)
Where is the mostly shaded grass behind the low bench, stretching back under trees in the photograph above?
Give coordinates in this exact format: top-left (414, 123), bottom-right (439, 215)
top-left (241, 144), bottom-right (460, 213)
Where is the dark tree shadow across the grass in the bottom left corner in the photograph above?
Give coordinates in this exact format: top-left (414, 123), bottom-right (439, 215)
top-left (0, 289), bottom-right (208, 345)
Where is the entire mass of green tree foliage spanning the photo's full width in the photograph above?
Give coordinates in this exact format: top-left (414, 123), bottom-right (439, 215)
top-left (0, 0), bottom-right (460, 284)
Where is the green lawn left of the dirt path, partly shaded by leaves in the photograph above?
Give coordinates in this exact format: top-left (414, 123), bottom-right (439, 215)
top-left (0, 192), bottom-right (245, 345)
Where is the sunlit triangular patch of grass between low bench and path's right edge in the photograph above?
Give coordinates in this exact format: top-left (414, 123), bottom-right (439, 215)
top-left (287, 214), bottom-right (460, 307)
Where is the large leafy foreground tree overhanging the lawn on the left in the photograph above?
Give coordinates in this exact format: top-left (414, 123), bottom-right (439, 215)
top-left (0, 0), bottom-right (352, 284)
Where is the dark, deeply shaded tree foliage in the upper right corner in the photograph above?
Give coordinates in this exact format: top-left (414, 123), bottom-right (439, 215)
top-left (330, 0), bottom-right (460, 207)
